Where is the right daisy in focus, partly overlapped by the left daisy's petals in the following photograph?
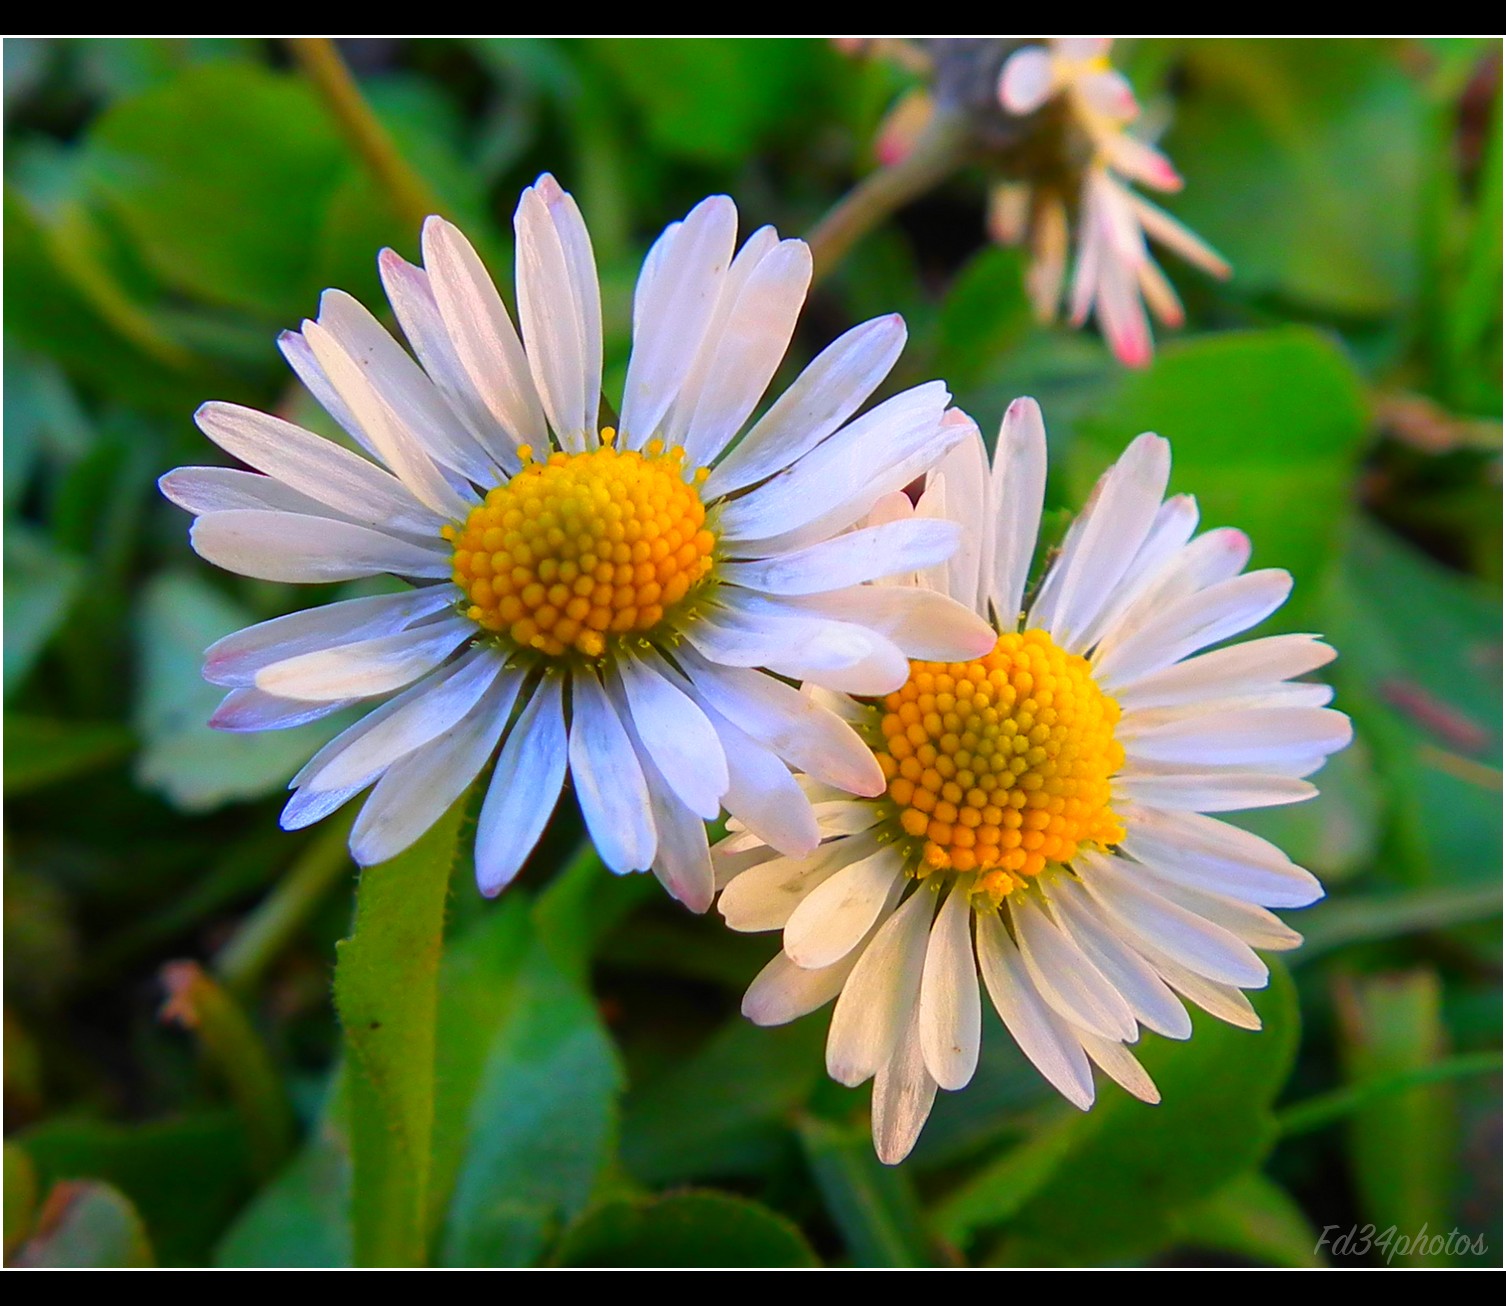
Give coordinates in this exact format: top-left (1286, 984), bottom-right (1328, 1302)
top-left (714, 399), bottom-right (1349, 1163)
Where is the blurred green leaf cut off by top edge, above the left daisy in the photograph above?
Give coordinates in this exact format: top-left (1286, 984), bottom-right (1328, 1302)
top-left (590, 38), bottom-right (830, 164)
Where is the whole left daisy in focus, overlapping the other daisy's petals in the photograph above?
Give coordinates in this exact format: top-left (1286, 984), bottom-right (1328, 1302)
top-left (161, 176), bottom-right (992, 910)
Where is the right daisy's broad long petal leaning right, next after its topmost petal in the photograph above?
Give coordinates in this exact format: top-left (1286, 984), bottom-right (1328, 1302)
top-left (1051, 435), bottom-right (1172, 652)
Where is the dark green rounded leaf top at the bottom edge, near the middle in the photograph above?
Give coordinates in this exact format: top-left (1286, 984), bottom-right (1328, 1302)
top-left (554, 1193), bottom-right (816, 1270)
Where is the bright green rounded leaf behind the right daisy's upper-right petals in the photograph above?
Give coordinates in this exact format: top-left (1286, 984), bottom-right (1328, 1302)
top-left (1068, 327), bottom-right (1366, 611)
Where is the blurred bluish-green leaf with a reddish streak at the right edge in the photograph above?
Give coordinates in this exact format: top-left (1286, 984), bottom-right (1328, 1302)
top-left (1327, 521), bottom-right (1501, 884)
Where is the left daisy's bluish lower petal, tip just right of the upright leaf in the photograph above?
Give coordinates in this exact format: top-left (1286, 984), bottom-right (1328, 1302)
top-left (476, 672), bottom-right (566, 898)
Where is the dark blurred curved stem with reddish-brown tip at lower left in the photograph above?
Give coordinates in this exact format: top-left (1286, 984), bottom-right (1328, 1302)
top-left (161, 961), bottom-right (294, 1178)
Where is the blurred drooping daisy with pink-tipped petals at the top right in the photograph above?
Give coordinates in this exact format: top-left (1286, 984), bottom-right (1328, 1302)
top-left (989, 36), bottom-right (1229, 366)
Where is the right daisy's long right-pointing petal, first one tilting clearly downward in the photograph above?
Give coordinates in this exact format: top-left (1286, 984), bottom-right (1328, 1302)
top-left (1120, 807), bottom-right (1322, 907)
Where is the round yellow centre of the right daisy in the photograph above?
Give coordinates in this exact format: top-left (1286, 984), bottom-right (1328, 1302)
top-left (876, 630), bottom-right (1125, 902)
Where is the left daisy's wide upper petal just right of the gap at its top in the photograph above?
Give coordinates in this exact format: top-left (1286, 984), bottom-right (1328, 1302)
top-left (622, 194), bottom-right (738, 449)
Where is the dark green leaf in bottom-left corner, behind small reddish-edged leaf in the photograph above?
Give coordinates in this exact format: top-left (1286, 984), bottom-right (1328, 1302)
top-left (17, 1112), bottom-right (252, 1265)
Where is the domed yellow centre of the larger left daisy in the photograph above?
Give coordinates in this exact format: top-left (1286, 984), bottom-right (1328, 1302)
top-left (443, 426), bottom-right (715, 658)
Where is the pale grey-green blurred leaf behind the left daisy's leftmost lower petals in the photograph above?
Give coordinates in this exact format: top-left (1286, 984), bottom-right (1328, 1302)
top-left (136, 572), bottom-right (343, 812)
